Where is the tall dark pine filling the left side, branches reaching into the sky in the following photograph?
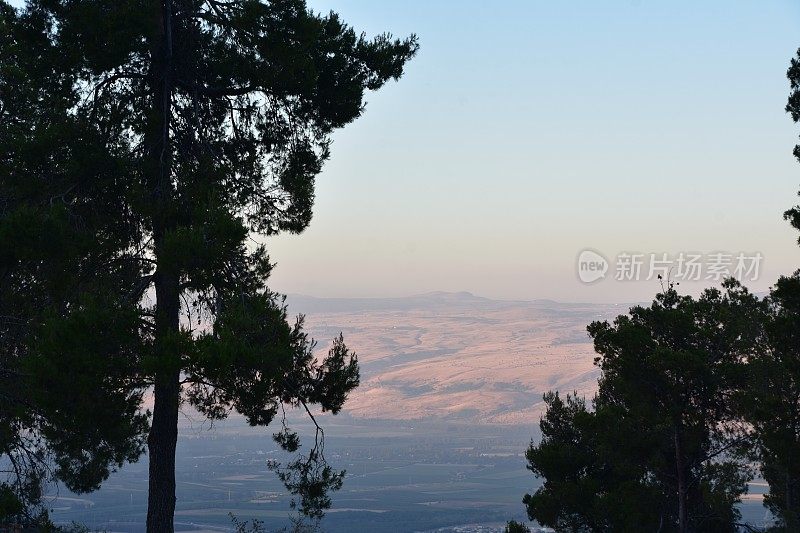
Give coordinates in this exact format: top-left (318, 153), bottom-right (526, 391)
top-left (0, 0), bottom-right (417, 532)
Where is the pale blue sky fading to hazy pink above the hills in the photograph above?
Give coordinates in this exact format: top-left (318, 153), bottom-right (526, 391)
top-left (10, 0), bottom-right (800, 302)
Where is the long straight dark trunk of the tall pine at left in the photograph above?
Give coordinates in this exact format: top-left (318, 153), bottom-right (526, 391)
top-left (145, 0), bottom-right (181, 533)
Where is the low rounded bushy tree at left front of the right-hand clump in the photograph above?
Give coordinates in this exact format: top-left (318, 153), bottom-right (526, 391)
top-left (523, 392), bottom-right (663, 532)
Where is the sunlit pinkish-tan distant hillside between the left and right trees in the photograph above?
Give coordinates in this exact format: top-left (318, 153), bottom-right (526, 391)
top-left (287, 292), bottom-right (628, 424)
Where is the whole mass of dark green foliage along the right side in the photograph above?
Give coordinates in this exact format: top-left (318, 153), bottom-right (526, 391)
top-left (523, 38), bottom-right (800, 532)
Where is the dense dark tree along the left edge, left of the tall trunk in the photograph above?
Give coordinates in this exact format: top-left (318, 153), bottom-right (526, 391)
top-left (0, 3), bottom-right (147, 524)
